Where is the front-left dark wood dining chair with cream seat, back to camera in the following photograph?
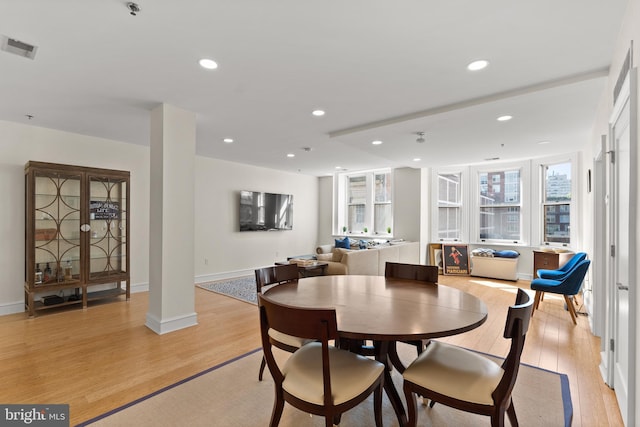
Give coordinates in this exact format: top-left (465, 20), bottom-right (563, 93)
top-left (258, 294), bottom-right (385, 427)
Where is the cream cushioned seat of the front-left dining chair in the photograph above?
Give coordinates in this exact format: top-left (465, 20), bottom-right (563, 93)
top-left (282, 342), bottom-right (384, 405)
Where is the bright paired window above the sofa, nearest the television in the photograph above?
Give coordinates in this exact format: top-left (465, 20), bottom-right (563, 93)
top-left (336, 170), bottom-right (393, 235)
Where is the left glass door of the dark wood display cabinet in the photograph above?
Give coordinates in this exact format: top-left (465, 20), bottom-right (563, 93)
top-left (33, 173), bottom-right (81, 286)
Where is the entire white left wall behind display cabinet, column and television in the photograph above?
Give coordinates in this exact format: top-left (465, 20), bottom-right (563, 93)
top-left (0, 121), bottom-right (318, 314)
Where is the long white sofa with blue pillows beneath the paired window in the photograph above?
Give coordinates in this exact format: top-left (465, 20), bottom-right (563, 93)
top-left (316, 242), bottom-right (420, 276)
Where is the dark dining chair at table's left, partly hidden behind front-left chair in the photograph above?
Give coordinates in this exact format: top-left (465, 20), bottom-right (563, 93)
top-left (255, 264), bottom-right (310, 381)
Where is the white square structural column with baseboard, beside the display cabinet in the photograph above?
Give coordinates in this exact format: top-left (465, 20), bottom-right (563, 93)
top-left (146, 104), bottom-right (198, 334)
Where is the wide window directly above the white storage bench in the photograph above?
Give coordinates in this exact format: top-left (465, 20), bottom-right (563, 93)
top-left (478, 169), bottom-right (522, 242)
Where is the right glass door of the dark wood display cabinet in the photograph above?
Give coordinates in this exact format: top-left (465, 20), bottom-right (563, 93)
top-left (88, 176), bottom-right (128, 283)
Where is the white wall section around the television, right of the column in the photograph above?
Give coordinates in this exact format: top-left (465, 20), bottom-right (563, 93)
top-left (194, 157), bottom-right (318, 282)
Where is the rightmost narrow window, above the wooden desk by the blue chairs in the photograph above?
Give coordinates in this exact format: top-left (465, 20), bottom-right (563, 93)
top-left (542, 162), bottom-right (571, 245)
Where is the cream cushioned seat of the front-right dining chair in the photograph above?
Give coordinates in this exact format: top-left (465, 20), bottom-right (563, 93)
top-left (402, 341), bottom-right (504, 405)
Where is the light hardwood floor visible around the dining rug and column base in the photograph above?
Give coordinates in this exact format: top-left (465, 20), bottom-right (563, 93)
top-left (0, 276), bottom-right (622, 426)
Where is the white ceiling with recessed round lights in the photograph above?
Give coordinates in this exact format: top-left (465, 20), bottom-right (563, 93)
top-left (0, 0), bottom-right (627, 176)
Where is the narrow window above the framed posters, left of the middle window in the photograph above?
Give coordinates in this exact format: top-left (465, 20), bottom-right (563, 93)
top-left (437, 173), bottom-right (462, 240)
